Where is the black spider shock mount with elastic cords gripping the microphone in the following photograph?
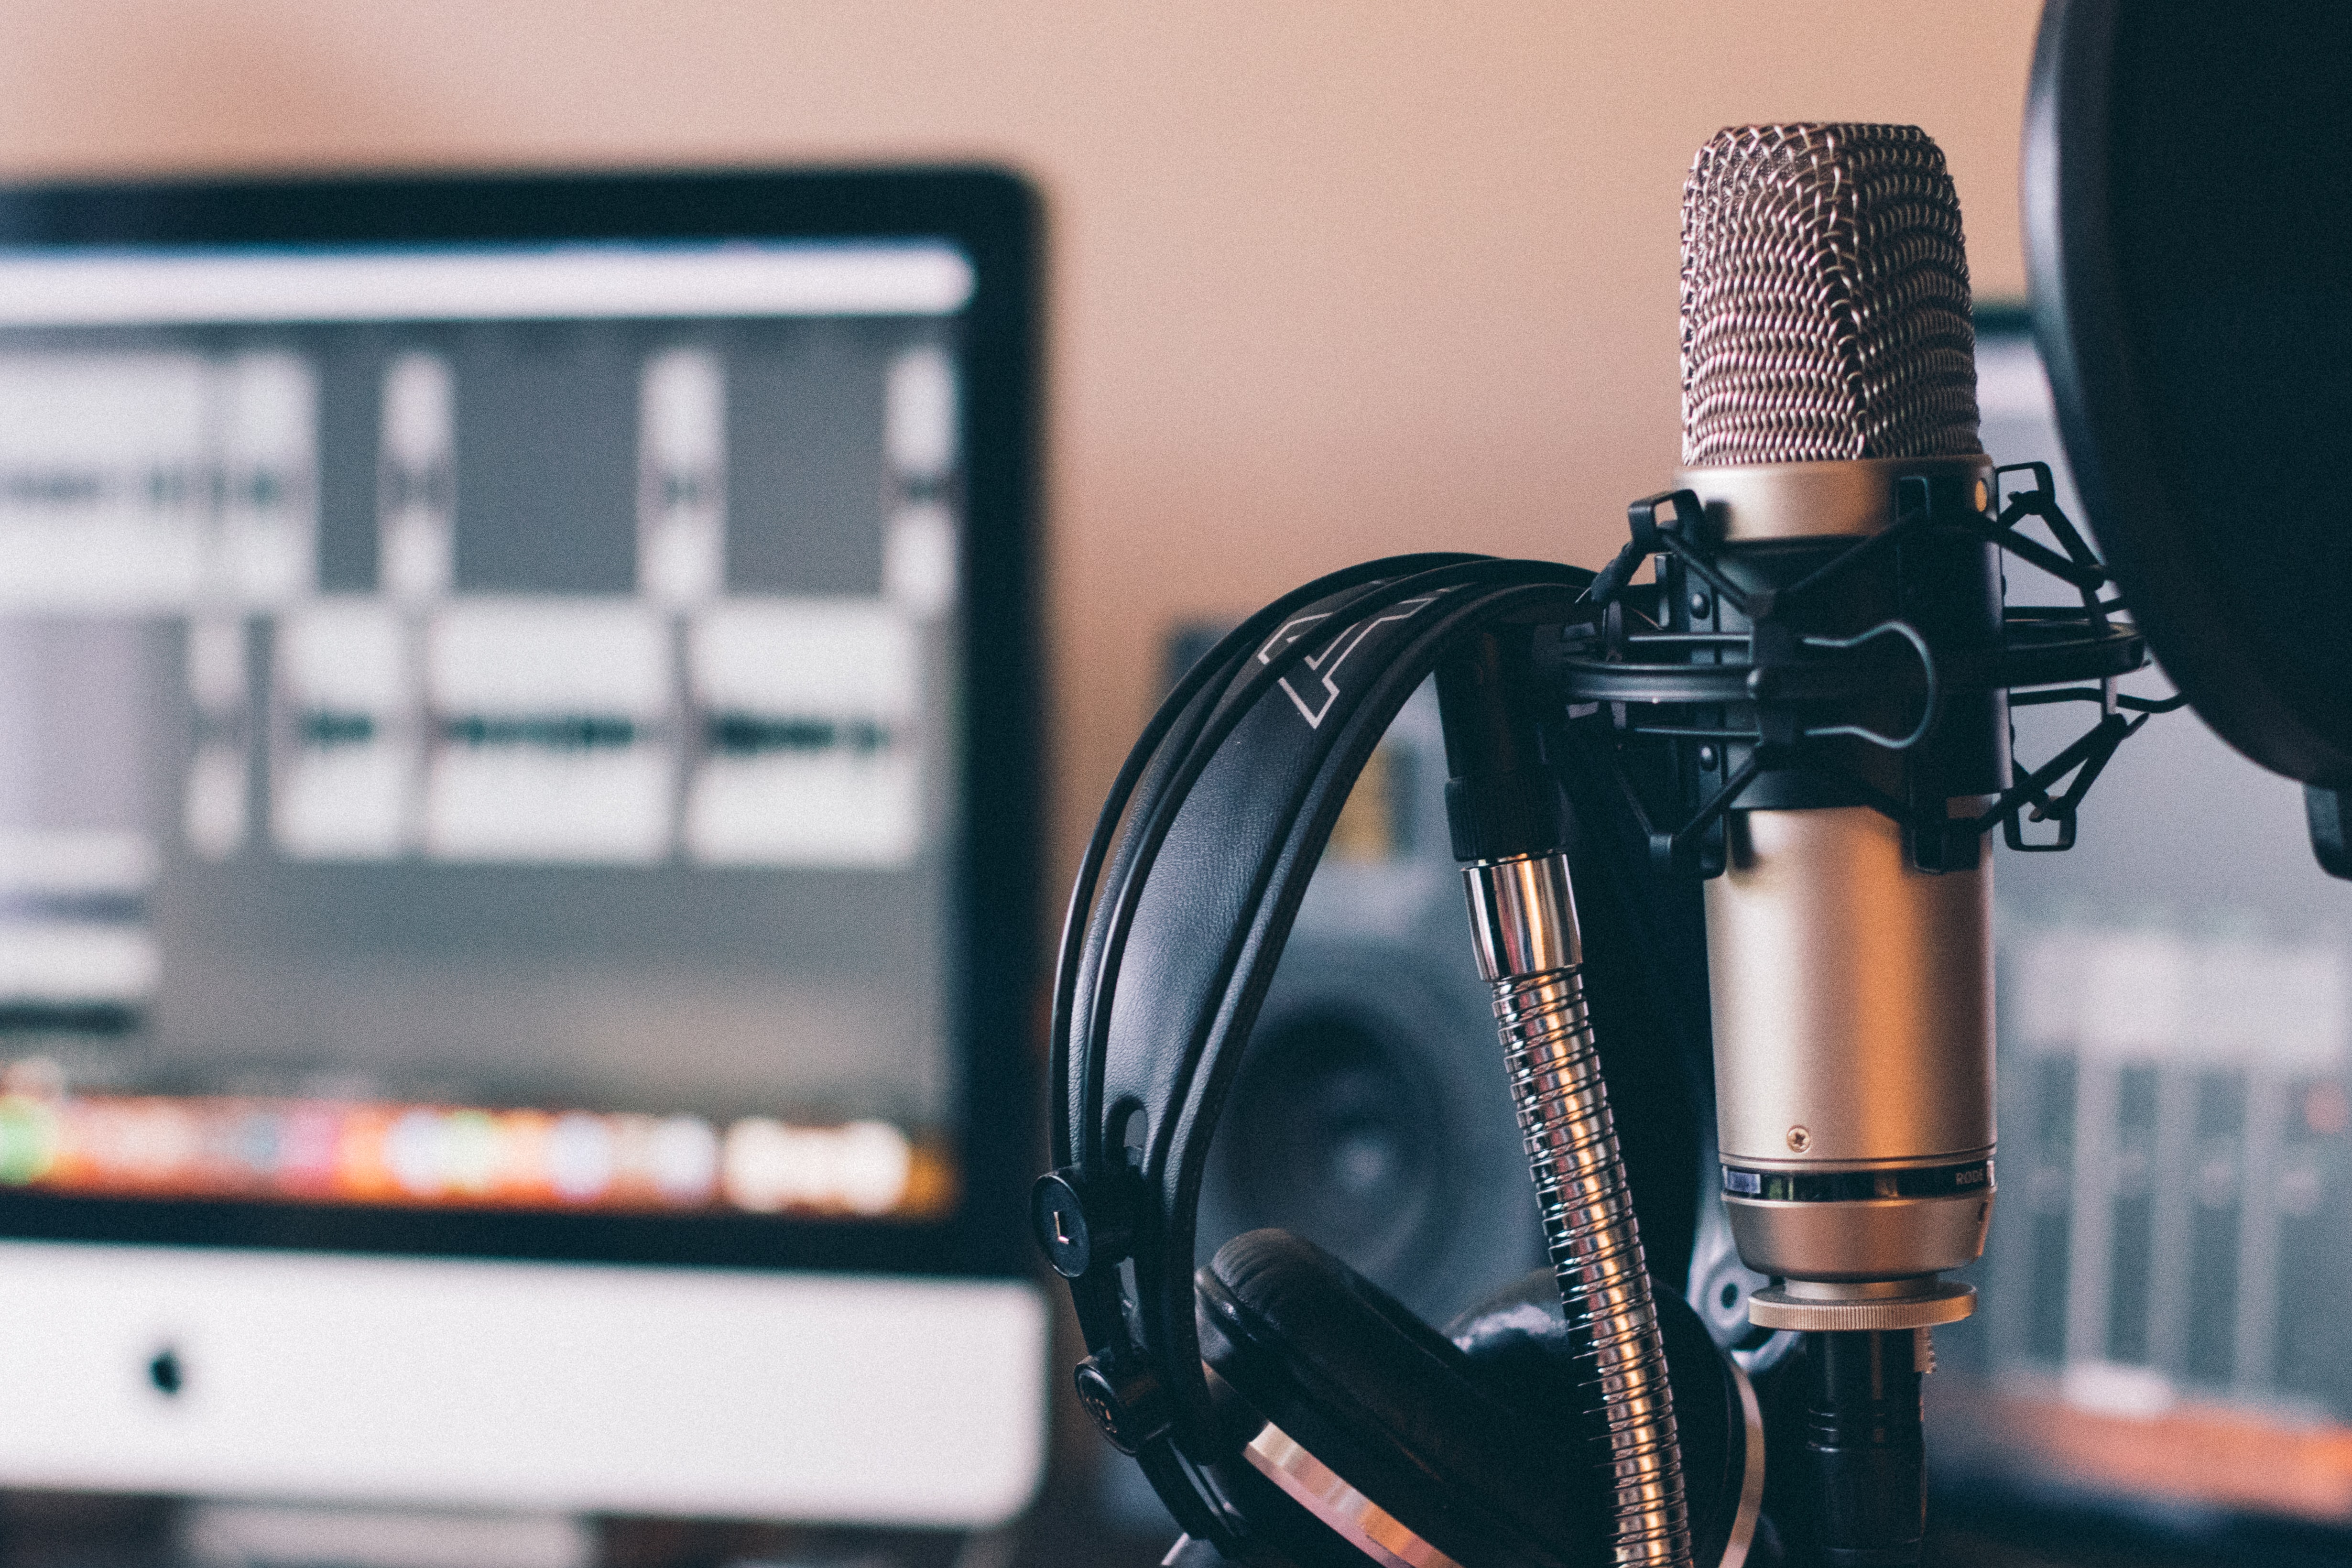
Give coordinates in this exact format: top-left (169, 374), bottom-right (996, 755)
top-left (1547, 463), bottom-right (2183, 877)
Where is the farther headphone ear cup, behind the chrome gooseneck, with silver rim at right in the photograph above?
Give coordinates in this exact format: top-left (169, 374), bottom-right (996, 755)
top-left (1447, 1269), bottom-right (1780, 1568)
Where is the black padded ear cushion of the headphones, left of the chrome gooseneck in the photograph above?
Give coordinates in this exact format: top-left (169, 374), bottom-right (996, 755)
top-left (1197, 1230), bottom-right (1609, 1568)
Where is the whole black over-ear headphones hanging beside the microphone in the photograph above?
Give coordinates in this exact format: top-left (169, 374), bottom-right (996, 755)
top-left (1030, 555), bottom-right (1769, 1568)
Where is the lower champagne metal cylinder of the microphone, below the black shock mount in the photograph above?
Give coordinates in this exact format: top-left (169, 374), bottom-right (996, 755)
top-left (1708, 806), bottom-right (1994, 1279)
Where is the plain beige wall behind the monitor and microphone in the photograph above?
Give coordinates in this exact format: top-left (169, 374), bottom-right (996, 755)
top-left (0, 0), bottom-right (2037, 883)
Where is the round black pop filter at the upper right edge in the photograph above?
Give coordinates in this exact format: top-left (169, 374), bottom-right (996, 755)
top-left (2025, 0), bottom-right (2352, 877)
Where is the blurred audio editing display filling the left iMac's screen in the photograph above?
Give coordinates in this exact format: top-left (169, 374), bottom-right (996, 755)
top-left (0, 244), bottom-right (971, 1215)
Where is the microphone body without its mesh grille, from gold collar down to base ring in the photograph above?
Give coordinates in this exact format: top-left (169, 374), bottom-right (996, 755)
top-left (1677, 456), bottom-right (2009, 1328)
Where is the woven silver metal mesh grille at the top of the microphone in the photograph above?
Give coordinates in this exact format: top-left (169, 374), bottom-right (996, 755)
top-left (1682, 125), bottom-right (1983, 468)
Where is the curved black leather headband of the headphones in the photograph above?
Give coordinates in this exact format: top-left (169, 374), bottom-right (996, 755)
top-left (1035, 555), bottom-right (1590, 1535)
